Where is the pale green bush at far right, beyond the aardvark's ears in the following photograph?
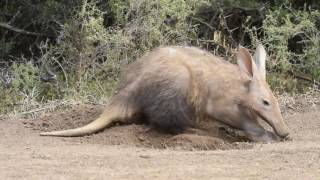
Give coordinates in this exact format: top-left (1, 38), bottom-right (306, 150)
top-left (262, 6), bottom-right (320, 91)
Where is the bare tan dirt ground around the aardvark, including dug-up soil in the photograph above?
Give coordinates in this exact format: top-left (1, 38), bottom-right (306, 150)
top-left (0, 97), bottom-right (320, 180)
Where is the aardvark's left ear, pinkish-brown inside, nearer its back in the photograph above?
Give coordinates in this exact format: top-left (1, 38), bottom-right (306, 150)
top-left (237, 46), bottom-right (257, 78)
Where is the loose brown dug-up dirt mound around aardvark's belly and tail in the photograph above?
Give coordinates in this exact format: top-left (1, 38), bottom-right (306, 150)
top-left (24, 105), bottom-right (253, 150)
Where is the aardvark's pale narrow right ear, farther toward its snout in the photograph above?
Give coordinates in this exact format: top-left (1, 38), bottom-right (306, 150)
top-left (253, 43), bottom-right (267, 79)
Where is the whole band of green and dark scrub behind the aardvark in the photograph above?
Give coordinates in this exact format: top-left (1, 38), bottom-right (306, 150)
top-left (0, 0), bottom-right (320, 112)
